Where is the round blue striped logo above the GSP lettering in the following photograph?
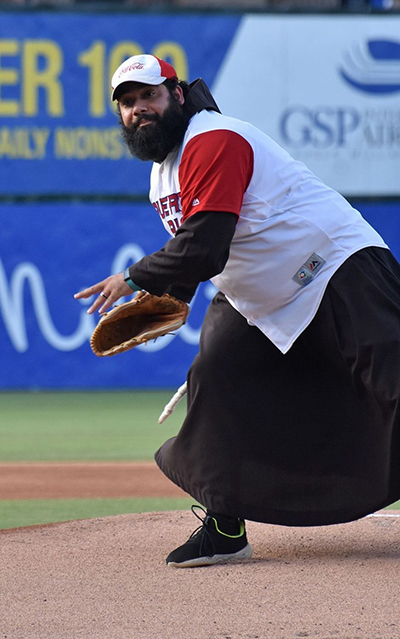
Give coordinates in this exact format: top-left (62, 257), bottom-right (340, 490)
top-left (339, 40), bottom-right (400, 95)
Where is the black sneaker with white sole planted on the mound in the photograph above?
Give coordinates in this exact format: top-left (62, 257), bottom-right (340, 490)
top-left (166, 506), bottom-right (253, 568)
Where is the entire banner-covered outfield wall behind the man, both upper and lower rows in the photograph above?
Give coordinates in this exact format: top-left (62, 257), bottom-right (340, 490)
top-left (0, 11), bottom-right (400, 389)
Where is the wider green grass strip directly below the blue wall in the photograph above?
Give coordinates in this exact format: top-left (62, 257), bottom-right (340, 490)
top-left (0, 390), bottom-right (186, 462)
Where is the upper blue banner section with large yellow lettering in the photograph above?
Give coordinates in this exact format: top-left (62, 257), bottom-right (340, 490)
top-left (0, 12), bottom-right (240, 195)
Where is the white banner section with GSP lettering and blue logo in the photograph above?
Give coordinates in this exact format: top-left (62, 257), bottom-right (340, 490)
top-left (213, 15), bottom-right (400, 196)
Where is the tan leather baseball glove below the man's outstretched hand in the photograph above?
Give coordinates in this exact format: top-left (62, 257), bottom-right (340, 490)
top-left (90, 293), bottom-right (189, 357)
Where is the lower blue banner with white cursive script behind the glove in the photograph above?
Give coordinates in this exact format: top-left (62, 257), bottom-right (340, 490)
top-left (0, 202), bottom-right (400, 389)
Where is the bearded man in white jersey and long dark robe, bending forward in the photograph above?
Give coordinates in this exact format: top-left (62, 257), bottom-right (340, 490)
top-left (76, 55), bottom-right (400, 567)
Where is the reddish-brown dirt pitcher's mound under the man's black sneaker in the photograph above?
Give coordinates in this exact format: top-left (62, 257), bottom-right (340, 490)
top-left (0, 512), bottom-right (400, 639)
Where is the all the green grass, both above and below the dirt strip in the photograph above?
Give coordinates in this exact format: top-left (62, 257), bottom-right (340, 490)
top-left (0, 390), bottom-right (400, 529)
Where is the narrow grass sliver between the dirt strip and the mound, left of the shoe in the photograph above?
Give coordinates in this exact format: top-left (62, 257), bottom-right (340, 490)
top-left (0, 497), bottom-right (200, 530)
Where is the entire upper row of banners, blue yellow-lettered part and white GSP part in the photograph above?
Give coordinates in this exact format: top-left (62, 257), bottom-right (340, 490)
top-left (0, 11), bottom-right (400, 196)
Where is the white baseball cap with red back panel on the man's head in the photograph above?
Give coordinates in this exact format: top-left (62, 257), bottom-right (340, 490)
top-left (111, 54), bottom-right (178, 100)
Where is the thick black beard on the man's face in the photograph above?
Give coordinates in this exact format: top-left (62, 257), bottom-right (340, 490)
top-left (120, 96), bottom-right (190, 163)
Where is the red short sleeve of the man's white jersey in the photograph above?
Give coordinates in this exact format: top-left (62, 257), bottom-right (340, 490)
top-left (179, 130), bottom-right (253, 221)
